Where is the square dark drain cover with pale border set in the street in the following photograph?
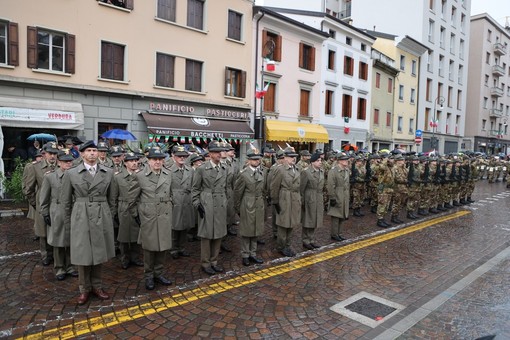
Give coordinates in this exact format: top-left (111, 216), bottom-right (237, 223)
top-left (330, 292), bottom-right (404, 328)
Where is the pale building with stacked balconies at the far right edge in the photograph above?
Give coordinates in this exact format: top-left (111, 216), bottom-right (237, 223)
top-left (466, 14), bottom-right (510, 154)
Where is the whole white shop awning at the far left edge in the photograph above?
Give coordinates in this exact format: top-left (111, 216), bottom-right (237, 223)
top-left (0, 96), bottom-right (84, 130)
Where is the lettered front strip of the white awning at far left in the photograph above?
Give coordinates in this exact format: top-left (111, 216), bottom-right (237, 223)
top-left (0, 107), bottom-right (76, 123)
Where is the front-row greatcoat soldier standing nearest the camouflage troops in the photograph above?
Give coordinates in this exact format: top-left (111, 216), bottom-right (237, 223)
top-left (327, 152), bottom-right (351, 242)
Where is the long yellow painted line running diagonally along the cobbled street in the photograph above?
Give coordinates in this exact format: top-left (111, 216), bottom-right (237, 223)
top-left (24, 210), bottom-right (471, 339)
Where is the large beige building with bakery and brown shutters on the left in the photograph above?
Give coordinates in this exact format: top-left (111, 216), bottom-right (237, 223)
top-left (0, 0), bottom-right (254, 177)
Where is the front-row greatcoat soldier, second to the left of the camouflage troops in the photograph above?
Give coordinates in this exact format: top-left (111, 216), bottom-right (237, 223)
top-left (300, 153), bottom-right (325, 250)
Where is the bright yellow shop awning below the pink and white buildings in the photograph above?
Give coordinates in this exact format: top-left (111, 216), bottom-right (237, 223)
top-left (266, 120), bottom-right (329, 143)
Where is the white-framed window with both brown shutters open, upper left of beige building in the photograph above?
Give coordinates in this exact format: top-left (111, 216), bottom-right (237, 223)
top-left (27, 26), bottom-right (75, 73)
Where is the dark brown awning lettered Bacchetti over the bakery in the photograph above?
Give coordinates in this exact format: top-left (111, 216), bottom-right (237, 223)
top-left (142, 112), bottom-right (254, 139)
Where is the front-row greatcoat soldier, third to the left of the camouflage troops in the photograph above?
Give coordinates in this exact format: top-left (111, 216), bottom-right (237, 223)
top-left (271, 147), bottom-right (301, 257)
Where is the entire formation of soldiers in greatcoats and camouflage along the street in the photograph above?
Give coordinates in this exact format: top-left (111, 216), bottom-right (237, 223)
top-left (16, 141), bottom-right (510, 304)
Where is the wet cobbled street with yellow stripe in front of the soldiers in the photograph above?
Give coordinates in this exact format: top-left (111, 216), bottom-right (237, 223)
top-left (0, 181), bottom-right (510, 339)
